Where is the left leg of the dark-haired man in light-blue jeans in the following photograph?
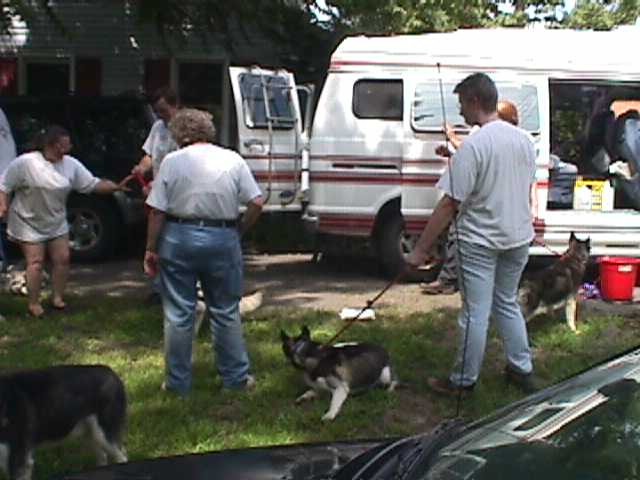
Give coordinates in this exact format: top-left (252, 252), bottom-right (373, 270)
top-left (449, 242), bottom-right (497, 387)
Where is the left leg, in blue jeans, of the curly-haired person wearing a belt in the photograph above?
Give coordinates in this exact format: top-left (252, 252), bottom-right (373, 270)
top-left (158, 223), bottom-right (197, 395)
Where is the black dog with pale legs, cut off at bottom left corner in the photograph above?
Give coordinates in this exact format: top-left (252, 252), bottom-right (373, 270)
top-left (0, 365), bottom-right (127, 480)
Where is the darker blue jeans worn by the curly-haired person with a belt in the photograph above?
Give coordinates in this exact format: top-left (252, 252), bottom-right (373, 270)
top-left (158, 222), bottom-right (249, 394)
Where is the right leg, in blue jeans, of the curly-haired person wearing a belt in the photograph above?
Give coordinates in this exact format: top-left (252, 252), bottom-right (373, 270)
top-left (200, 229), bottom-right (250, 388)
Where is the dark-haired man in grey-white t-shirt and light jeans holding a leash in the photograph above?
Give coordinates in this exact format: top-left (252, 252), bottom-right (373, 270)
top-left (407, 73), bottom-right (536, 395)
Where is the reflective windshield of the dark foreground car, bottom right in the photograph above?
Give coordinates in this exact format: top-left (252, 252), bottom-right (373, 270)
top-left (422, 349), bottom-right (640, 480)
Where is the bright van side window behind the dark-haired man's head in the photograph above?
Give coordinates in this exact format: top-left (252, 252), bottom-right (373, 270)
top-left (411, 81), bottom-right (540, 134)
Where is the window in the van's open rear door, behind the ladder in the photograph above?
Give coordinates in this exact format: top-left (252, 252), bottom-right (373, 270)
top-left (239, 73), bottom-right (296, 130)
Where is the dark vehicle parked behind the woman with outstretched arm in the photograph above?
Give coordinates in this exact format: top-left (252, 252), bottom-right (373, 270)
top-left (0, 95), bottom-right (153, 260)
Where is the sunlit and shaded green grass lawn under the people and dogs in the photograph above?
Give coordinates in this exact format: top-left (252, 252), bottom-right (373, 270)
top-left (0, 297), bottom-right (640, 479)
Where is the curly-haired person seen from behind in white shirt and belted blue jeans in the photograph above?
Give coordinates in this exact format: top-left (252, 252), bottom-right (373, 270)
top-left (144, 108), bottom-right (263, 395)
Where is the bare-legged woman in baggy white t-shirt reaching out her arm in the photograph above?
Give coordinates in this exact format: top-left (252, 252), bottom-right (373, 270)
top-left (0, 125), bottom-right (125, 317)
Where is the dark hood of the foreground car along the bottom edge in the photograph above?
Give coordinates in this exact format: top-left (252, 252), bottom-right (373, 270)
top-left (56, 440), bottom-right (390, 480)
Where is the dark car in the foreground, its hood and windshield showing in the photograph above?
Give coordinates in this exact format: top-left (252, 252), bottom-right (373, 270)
top-left (56, 347), bottom-right (640, 480)
